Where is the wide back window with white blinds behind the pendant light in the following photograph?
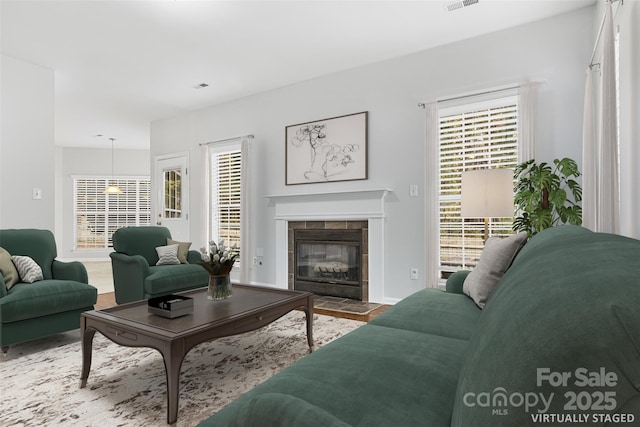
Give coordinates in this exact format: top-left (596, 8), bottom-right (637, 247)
top-left (73, 177), bottom-right (151, 249)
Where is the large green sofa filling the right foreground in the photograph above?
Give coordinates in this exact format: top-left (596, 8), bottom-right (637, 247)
top-left (200, 226), bottom-right (640, 427)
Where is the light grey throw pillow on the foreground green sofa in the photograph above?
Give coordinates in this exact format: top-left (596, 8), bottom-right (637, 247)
top-left (463, 231), bottom-right (527, 308)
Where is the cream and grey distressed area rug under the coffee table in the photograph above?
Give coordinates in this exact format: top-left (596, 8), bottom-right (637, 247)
top-left (0, 311), bottom-right (363, 427)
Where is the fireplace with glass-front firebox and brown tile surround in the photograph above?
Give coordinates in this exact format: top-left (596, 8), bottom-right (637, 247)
top-left (289, 221), bottom-right (368, 301)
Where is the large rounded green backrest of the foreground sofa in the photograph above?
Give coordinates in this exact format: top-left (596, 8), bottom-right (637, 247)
top-left (451, 226), bottom-right (640, 427)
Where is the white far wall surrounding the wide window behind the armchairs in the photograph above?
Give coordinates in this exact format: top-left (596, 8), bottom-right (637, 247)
top-left (56, 147), bottom-right (150, 260)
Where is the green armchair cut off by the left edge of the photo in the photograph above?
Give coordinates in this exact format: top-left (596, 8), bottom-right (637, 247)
top-left (0, 229), bottom-right (98, 353)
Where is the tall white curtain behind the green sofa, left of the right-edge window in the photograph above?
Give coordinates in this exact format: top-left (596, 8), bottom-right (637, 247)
top-left (597, 3), bottom-right (620, 233)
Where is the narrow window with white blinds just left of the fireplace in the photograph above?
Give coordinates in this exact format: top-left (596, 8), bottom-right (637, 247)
top-left (209, 142), bottom-right (242, 253)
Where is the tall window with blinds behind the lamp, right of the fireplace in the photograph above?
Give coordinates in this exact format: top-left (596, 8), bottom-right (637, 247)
top-left (438, 96), bottom-right (518, 277)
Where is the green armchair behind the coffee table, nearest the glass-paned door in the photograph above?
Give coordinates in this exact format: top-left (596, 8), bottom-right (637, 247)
top-left (109, 226), bottom-right (209, 304)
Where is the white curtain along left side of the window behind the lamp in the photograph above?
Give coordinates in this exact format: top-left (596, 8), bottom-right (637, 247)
top-left (425, 102), bottom-right (440, 288)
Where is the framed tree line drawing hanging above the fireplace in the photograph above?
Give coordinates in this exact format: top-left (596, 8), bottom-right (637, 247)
top-left (285, 111), bottom-right (368, 185)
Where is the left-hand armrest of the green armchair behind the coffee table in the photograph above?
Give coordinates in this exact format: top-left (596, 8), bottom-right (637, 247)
top-left (109, 252), bottom-right (151, 304)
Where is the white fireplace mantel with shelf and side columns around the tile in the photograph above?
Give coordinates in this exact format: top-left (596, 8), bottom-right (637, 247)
top-left (267, 189), bottom-right (392, 303)
